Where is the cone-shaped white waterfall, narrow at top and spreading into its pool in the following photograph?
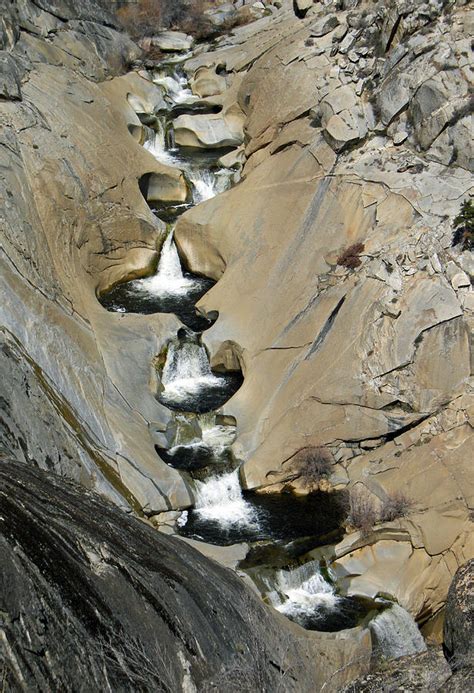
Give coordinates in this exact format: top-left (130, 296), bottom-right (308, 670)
top-left (136, 231), bottom-right (197, 296)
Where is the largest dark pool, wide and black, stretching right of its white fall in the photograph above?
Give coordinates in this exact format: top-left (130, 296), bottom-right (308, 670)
top-left (180, 492), bottom-right (346, 546)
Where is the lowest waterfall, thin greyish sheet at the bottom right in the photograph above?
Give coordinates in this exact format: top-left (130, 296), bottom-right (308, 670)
top-left (369, 604), bottom-right (426, 659)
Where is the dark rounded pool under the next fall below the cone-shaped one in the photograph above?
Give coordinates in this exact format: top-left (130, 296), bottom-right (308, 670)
top-left (157, 371), bottom-right (244, 414)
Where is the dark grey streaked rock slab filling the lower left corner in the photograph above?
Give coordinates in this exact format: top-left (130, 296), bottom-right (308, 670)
top-left (0, 459), bottom-right (310, 693)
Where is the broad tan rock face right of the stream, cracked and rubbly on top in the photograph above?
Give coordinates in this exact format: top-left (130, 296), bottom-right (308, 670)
top-left (175, 2), bottom-right (474, 642)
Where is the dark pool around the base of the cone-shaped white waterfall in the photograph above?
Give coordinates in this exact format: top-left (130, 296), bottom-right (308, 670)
top-left (99, 273), bottom-right (217, 332)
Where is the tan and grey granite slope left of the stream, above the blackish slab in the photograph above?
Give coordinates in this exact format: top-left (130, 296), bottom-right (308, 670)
top-left (0, 2), bottom-right (194, 513)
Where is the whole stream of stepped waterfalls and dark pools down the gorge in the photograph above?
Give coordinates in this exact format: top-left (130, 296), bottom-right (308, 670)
top-left (99, 60), bottom-right (425, 656)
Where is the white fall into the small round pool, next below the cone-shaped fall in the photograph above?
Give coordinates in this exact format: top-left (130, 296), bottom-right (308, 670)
top-left (161, 341), bottom-right (221, 404)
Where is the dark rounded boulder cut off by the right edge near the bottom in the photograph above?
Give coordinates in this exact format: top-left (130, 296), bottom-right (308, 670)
top-left (444, 559), bottom-right (474, 671)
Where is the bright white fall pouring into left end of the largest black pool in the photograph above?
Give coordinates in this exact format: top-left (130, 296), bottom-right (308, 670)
top-left (195, 469), bottom-right (258, 527)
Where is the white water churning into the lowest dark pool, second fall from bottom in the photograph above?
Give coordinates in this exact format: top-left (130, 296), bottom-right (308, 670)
top-left (268, 561), bottom-right (339, 621)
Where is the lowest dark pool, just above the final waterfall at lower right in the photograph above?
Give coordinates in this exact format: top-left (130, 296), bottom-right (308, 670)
top-left (285, 597), bottom-right (380, 633)
